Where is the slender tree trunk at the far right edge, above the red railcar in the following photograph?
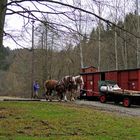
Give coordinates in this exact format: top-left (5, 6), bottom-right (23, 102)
top-left (136, 0), bottom-right (140, 68)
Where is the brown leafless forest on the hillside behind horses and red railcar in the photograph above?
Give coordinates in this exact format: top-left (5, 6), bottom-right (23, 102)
top-left (0, 13), bottom-right (137, 97)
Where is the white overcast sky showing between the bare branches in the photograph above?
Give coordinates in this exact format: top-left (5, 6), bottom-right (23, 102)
top-left (3, 0), bottom-right (137, 49)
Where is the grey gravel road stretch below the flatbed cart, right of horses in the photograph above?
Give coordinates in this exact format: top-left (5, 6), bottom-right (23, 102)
top-left (75, 100), bottom-right (140, 117)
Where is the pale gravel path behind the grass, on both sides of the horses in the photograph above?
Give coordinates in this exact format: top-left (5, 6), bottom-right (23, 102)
top-left (0, 96), bottom-right (140, 117)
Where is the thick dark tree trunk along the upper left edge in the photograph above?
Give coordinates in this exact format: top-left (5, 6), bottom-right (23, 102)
top-left (0, 0), bottom-right (7, 47)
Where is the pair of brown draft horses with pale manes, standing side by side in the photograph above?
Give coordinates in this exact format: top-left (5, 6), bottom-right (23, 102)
top-left (44, 76), bottom-right (84, 101)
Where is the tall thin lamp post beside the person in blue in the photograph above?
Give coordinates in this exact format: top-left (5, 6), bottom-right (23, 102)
top-left (31, 20), bottom-right (35, 98)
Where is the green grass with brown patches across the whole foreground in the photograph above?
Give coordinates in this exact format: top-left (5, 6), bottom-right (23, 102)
top-left (0, 102), bottom-right (140, 140)
